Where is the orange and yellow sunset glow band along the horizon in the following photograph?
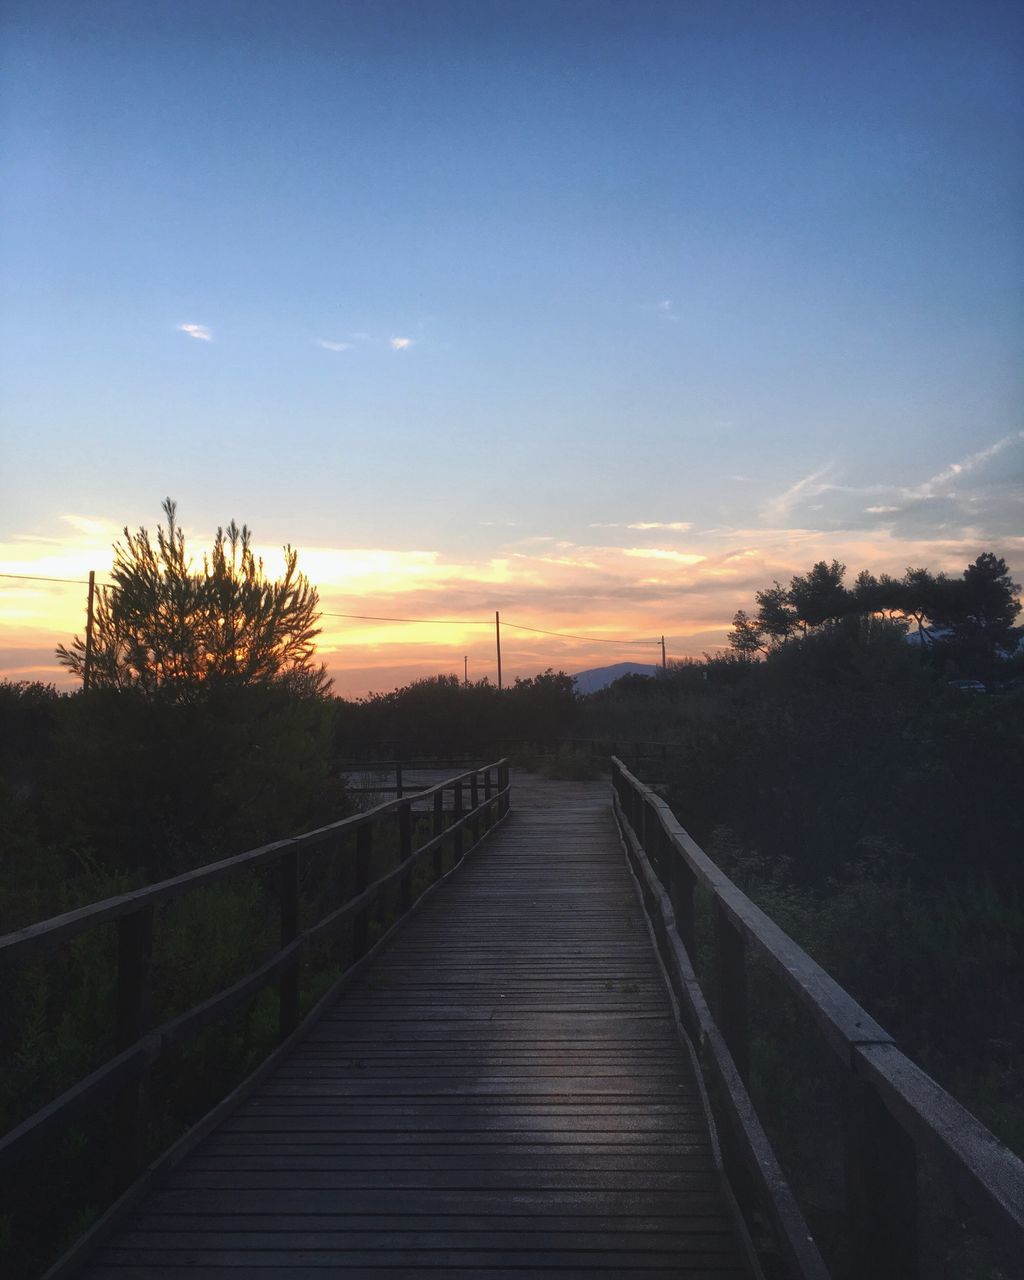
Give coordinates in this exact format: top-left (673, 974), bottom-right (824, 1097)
top-left (0, 516), bottom-right (1024, 698)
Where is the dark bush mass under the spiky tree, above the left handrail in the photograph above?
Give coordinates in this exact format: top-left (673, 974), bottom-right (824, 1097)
top-left (0, 682), bottom-right (349, 931)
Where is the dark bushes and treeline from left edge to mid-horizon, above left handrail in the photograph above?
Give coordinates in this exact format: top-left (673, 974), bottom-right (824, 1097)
top-left (0, 672), bottom-right (580, 931)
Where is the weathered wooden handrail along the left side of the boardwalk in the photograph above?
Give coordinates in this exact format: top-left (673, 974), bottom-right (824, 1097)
top-left (0, 759), bottom-right (511, 1172)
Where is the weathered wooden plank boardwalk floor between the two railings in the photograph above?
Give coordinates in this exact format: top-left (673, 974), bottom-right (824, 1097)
top-left (83, 777), bottom-right (748, 1280)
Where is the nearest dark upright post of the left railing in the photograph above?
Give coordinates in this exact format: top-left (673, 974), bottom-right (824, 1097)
top-left (114, 906), bottom-right (154, 1180)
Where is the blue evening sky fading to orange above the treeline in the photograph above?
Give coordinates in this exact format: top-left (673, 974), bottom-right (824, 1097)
top-left (0, 0), bottom-right (1024, 696)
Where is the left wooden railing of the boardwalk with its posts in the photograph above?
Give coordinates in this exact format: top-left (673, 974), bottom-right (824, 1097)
top-left (0, 760), bottom-right (509, 1239)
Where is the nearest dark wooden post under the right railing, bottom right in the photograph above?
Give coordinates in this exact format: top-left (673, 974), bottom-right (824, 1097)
top-left (840, 1065), bottom-right (920, 1280)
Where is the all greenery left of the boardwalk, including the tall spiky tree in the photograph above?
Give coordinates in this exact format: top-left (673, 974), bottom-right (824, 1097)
top-left (0, 499), bottom-right (349, 1276)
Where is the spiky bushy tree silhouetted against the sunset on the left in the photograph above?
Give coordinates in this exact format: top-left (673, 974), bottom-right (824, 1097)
top-left (56, 498), bottom-right (330, 701)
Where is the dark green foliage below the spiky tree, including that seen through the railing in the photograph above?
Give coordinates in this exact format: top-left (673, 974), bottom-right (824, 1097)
top-left (0, 680), bottom-right (351, 1277)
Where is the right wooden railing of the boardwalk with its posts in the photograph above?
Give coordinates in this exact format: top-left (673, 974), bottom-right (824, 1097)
top-left (612, 759), bottom-right (1024, 1280)
